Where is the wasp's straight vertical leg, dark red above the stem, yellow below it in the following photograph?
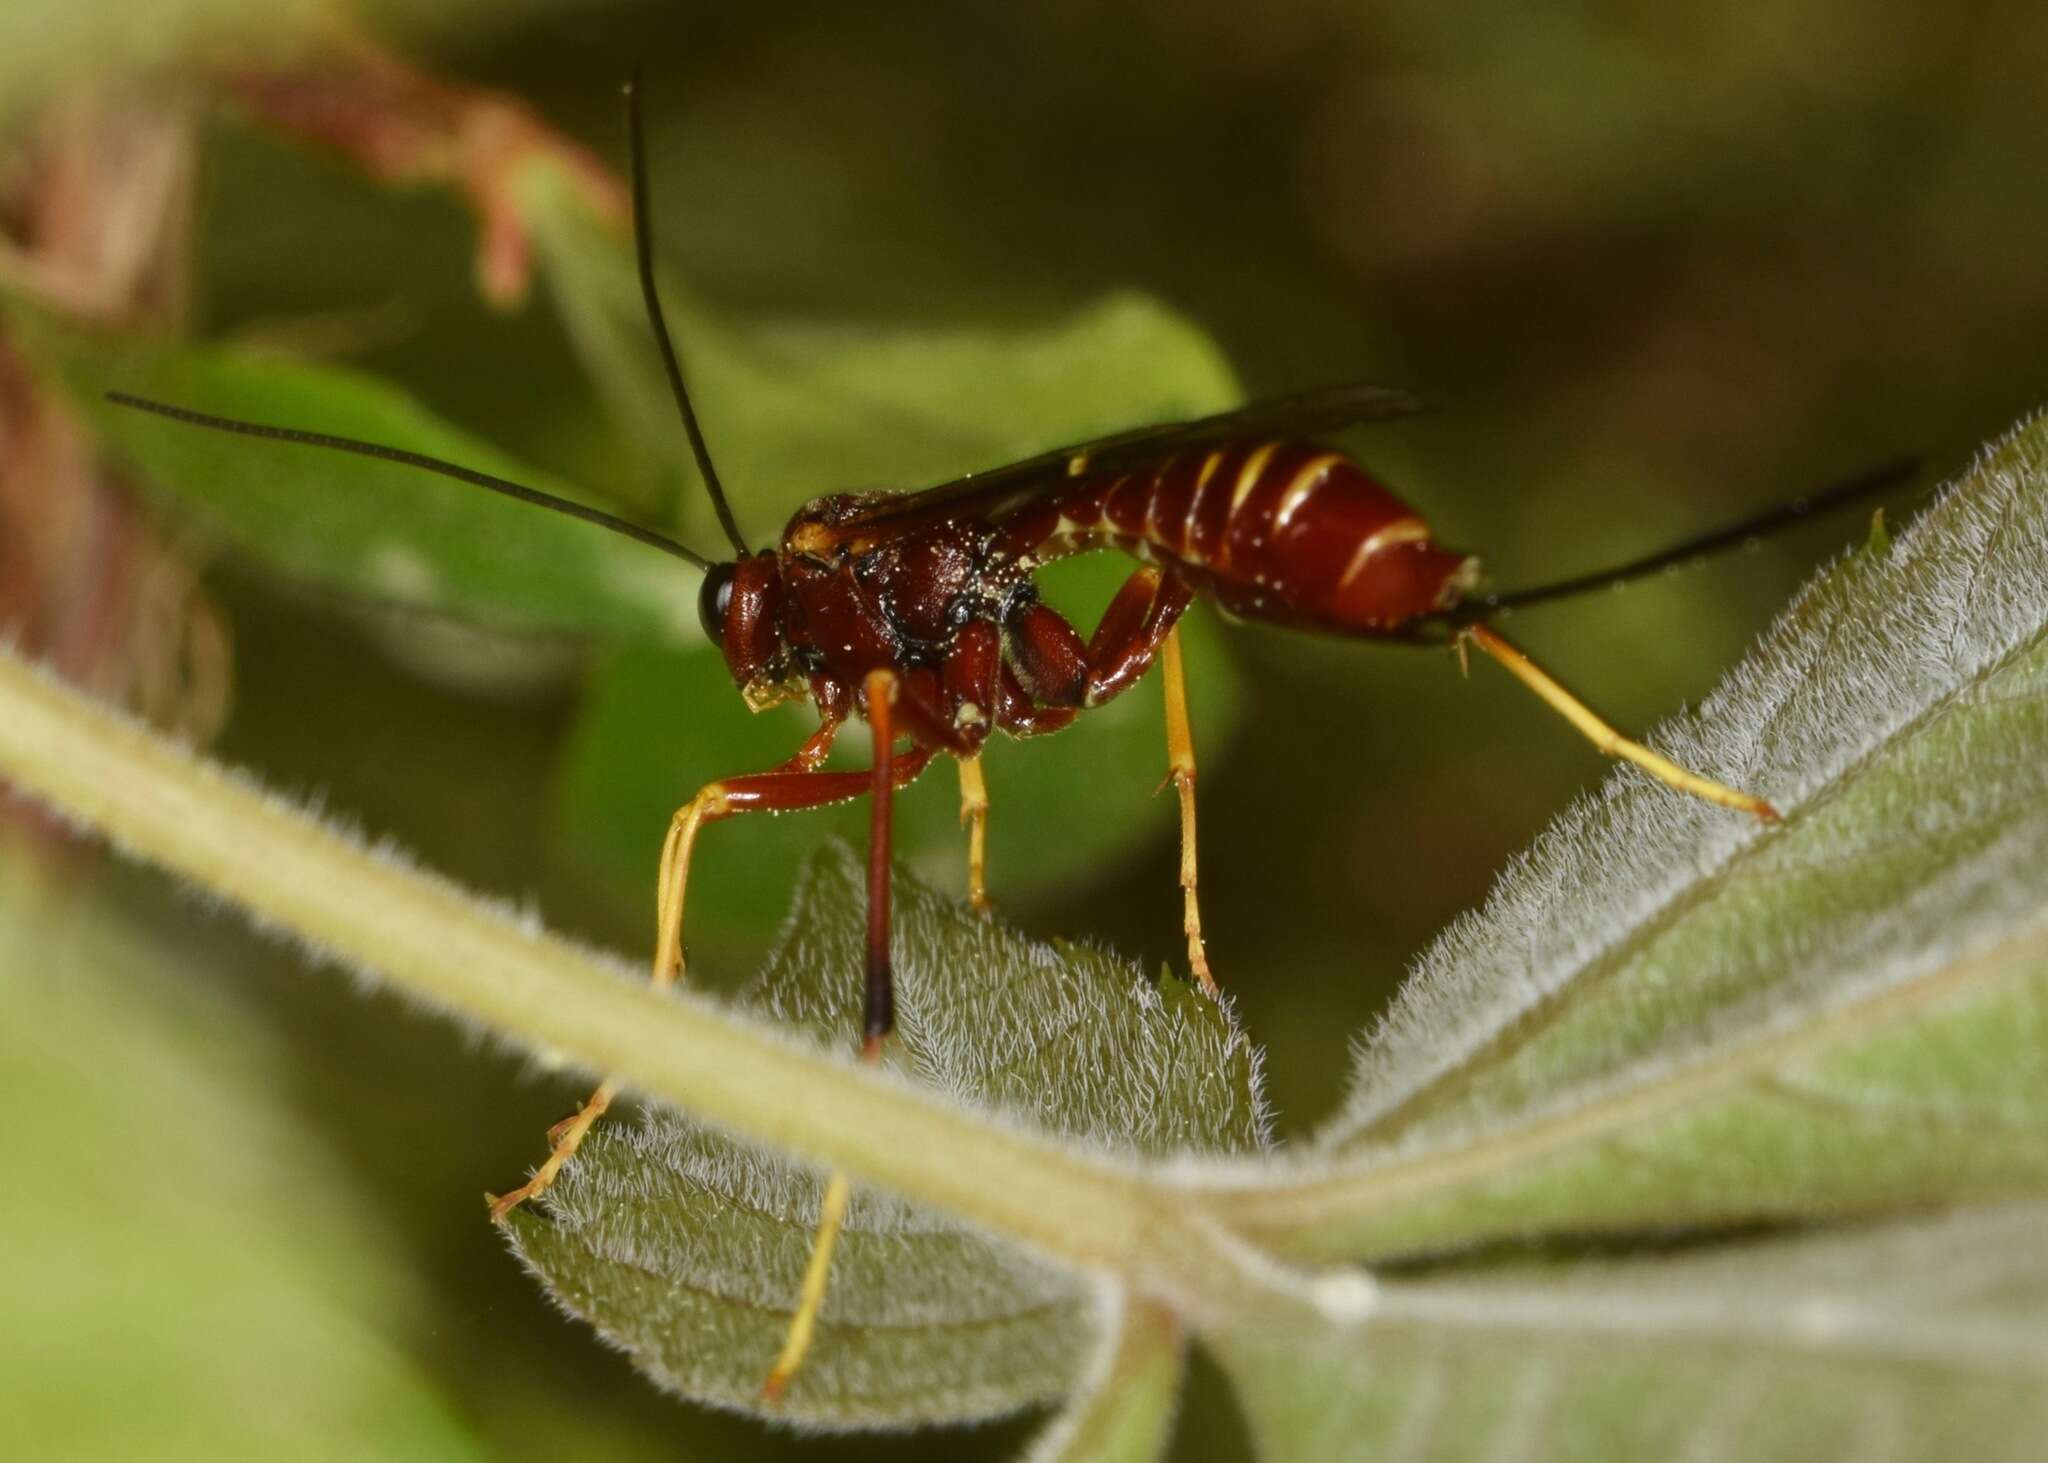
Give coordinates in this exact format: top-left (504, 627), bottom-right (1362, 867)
top-left (762, 668), bottom-right (905, 1402)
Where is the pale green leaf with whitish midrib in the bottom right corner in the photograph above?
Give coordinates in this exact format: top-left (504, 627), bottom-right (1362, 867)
top-left (1212, 1203), bottom-right (2048, 1463)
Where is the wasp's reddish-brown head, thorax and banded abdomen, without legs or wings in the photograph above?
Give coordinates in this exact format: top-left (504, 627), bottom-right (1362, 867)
top-left (707, 438), bottom-right (1477, 756)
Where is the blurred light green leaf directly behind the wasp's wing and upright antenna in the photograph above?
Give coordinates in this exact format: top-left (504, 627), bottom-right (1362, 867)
top-left (520, 166), bottom-right (1241, 547)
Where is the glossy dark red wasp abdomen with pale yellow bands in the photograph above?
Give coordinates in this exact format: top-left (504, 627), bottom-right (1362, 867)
top-left (1032, 443), bottom-right (1477, 633)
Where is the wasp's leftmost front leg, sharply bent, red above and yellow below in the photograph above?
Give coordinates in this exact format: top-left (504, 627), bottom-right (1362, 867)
top-left (487, 738), bottom-right (932, 1219)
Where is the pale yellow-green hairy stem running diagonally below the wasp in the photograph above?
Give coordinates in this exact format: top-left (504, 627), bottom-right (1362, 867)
top-left (0, 652), bottom-right (1276, 1313)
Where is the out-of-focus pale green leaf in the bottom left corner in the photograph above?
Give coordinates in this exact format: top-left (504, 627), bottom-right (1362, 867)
top-left (0, 856), bottom-right (483, 1463)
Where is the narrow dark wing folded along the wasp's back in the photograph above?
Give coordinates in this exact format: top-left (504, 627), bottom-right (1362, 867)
top-left (834, 381), bottom-right (1430, 537)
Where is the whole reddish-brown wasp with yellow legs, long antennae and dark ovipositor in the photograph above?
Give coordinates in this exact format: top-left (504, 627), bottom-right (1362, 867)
top-left (99, 76), bottom-right (1915, 1397)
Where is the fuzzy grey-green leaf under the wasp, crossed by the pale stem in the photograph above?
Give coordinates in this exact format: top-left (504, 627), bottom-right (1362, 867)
top-left (512, 844), bottom-right (1266, 1428)
